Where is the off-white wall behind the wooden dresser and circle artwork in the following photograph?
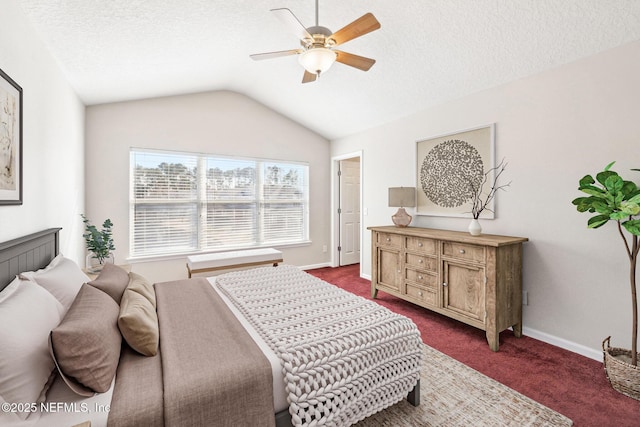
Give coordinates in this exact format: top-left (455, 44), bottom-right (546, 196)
top-left (331, 42), bottom-right (640, 358)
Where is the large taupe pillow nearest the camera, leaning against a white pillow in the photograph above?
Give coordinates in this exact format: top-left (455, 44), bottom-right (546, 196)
top-left (49, 284), bottom-right (122, 396)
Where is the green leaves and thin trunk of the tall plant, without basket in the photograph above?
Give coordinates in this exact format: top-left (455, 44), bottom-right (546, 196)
top-left (572, 162), bottom-right (640, 366)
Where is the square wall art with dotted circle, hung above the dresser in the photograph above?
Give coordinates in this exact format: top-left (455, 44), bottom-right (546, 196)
top-left (416, 123), bottom-right (495, 219)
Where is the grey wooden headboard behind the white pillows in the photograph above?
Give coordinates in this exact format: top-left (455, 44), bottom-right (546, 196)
top-left (0, 228), bottom-right (61, 291)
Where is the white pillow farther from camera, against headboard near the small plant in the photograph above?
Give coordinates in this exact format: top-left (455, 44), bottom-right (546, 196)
top-left (20, 254), bottom-right (91, 313)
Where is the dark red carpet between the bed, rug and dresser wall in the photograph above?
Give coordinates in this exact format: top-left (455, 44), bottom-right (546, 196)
top-left (308, 264), bottom-right (640, 427)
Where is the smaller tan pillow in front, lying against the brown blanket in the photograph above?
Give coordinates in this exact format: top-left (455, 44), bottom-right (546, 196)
top-left (118, 273), bottom-right (160, 356)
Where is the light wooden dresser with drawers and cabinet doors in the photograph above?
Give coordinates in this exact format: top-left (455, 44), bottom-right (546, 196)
top-left (368, 226), bottom-right (528, 351)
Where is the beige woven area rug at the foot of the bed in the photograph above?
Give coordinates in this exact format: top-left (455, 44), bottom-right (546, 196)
top-left (356, 345), bottom-right (573, 427)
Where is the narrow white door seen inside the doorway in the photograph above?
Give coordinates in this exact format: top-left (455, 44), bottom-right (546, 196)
top-left (338, 157), bottom-right (360, 265)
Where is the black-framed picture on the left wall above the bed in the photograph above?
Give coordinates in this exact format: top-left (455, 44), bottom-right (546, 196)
top-left (0, 70), bottom-right (22, 205)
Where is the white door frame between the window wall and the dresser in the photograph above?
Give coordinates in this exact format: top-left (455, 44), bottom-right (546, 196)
top-left (331, 150), bottom-right (364, 276)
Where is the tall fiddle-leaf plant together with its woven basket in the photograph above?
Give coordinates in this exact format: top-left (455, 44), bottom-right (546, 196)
top-left (572, 162), bottom-right (640, 400)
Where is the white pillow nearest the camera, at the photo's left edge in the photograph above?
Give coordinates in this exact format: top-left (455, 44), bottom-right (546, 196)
top-left (0, 278), bottom-right (64, 420)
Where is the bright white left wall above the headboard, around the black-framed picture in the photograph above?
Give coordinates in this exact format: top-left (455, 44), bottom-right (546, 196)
top-left (0, 1), bottom-right (84, 262)
